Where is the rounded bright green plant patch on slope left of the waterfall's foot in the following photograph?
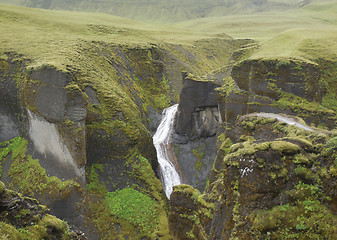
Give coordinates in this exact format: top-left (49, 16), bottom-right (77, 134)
top-left (105, 188), bottom-right (159, 236)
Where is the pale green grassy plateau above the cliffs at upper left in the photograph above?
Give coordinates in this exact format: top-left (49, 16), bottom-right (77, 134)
top-left (0, 4), bottom-right (231, 69)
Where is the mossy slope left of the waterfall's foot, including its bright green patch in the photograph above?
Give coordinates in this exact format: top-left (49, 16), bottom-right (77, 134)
top-left (86, 153), bottom-right (169, 240)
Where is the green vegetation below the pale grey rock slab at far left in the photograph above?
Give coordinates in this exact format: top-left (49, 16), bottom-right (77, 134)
top-left (0, 137), bottom-right (80, 198)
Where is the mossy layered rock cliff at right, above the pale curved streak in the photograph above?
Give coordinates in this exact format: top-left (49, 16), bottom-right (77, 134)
top-left (218, 59), bottom-right (337, 129)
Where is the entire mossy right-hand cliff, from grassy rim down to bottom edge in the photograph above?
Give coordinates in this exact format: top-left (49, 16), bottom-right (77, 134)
top-left (169, 50), bottom-right (336, 239)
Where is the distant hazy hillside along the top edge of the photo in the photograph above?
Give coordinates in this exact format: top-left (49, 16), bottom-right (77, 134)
top-left (0, 0), bottom-right (310, 22)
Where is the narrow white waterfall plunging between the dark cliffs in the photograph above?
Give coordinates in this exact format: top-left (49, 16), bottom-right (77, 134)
top-left (153, 104), bottom-right (181, 198)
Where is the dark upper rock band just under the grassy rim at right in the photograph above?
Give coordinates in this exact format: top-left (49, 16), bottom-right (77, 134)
top-left (232, 59), bottom-right (326, 101)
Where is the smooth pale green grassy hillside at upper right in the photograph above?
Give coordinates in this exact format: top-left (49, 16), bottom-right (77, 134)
top-left (176, 0), bottom-right (337, 41)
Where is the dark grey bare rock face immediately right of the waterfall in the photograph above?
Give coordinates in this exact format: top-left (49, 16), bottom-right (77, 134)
top-left (173, 72), bottom-right (221, 191)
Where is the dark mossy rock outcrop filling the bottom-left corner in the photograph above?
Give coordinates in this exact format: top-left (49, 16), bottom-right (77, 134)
top-left (0, 182), bottom-right (87, 240)
